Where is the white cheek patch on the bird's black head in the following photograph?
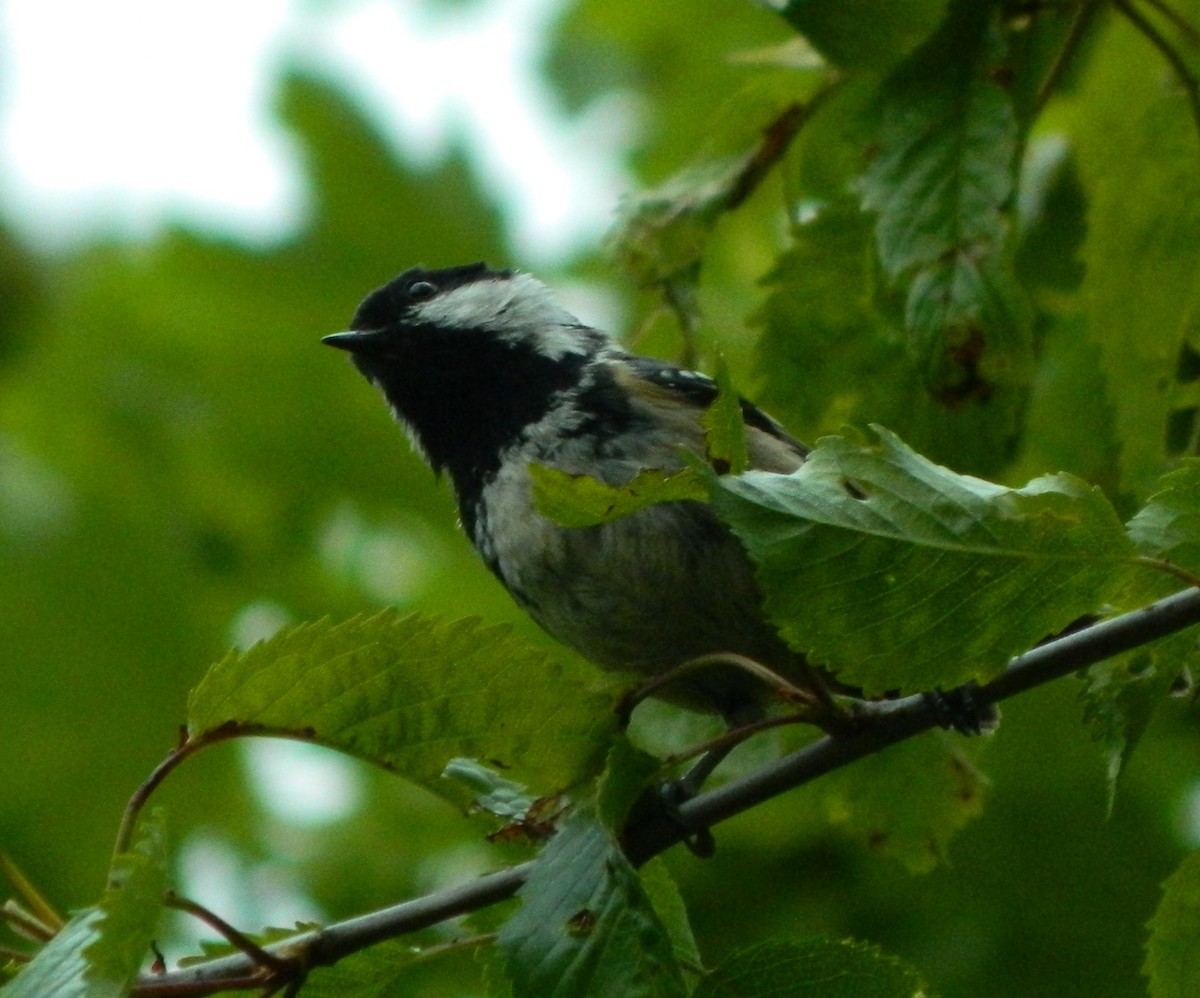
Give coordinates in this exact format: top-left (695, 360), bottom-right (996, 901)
top-left (412, 273), bottom-right (595, 360)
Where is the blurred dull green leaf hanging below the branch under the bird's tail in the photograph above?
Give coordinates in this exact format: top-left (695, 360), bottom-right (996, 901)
top-left (818, 732), bottom-right (986, 873)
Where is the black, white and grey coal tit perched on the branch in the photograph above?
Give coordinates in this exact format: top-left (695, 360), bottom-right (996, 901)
top-left (324, 263), bottom-right (812, 726)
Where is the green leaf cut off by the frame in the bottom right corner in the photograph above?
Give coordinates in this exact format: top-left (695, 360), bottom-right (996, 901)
top-left (1144, 853), bottom-right (1200, 998)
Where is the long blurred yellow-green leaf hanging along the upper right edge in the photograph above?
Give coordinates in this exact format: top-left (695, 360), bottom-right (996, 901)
top-left (1072, 18), bottom-right (1200, 495)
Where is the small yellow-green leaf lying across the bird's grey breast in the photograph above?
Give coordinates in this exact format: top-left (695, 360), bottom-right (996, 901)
top-left (529, 464), bottom-right (708, 528)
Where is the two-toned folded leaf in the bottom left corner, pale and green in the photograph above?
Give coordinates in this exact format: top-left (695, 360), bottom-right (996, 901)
top-left (4, 811), bottom-right (167, 998)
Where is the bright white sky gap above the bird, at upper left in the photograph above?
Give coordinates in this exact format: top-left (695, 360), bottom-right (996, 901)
top-left (0, 0), bottom-right (632, 263)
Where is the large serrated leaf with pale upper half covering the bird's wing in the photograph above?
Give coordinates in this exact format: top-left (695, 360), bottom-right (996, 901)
top-left (713, 427), bottom-right (1134, 696)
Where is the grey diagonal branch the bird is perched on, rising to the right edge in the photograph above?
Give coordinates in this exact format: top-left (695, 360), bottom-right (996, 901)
top-left (132, 589), bottom-right (1200, 998)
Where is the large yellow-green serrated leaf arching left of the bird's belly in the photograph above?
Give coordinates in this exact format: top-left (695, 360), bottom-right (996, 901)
top-left (188, 609), bottom-right (617, 804)
